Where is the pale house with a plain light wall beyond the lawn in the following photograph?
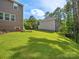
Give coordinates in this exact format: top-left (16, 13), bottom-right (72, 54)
top-left (38, 17), bottom-right (59, 31)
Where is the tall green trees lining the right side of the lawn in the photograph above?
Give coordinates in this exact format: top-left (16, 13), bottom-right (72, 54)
top-left (49, 0), bottom-right (79, 42)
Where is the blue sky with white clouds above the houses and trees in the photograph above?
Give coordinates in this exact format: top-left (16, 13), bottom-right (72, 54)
top-left (17, 0), bottom-right (66, 19)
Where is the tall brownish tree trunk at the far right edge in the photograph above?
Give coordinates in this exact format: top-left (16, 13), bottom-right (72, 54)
top-left (72, 0), bottom-right (79, 42)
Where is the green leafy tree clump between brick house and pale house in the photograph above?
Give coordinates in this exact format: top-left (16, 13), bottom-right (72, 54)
top-left (24, 15), bottom-right (38, 29)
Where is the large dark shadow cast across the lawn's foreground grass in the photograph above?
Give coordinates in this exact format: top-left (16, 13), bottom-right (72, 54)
top-left (10, 37), bottom-right (79, 59)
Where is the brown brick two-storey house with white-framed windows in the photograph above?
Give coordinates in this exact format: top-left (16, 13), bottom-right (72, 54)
top-left (0, 0), bottom-right (23, 31)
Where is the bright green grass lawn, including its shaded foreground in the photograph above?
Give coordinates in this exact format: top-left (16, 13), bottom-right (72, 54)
top-left (0, 31), bottom-right (79, 59)
